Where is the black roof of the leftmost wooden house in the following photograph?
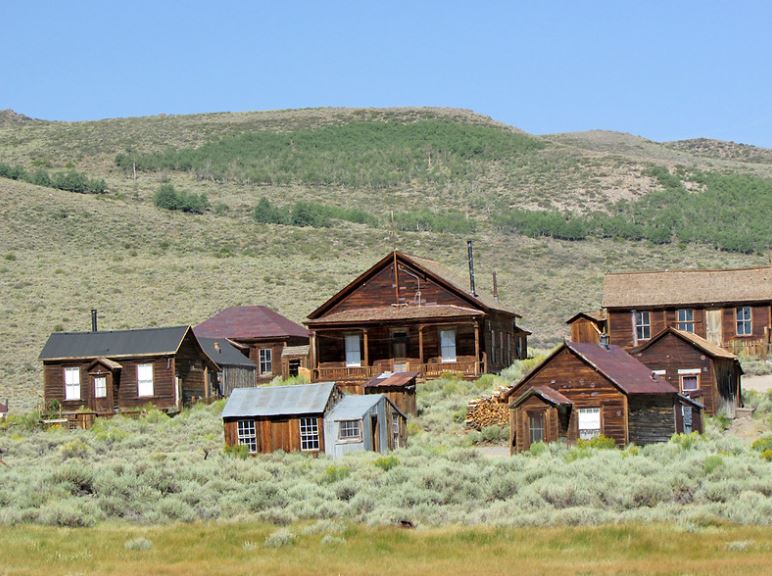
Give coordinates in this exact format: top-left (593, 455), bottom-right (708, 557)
top-left (40, 326), bottom-right (190, 360)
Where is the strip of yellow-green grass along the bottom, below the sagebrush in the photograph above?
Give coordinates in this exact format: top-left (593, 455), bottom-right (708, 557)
top-left (0, 523), bottom-right (772, 576)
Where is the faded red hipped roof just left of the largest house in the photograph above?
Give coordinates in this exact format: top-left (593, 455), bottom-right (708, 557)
top-left (193, 306), bottom-right (308, 339)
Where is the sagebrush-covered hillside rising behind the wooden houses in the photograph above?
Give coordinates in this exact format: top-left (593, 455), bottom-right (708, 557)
top-left (0, 109), bottom-right (772, 408)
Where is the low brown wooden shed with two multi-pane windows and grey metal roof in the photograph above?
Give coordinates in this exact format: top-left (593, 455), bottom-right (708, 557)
top-left (222, 382), bottom-right (342, 454)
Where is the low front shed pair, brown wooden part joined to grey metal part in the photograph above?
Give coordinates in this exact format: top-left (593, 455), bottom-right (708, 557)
top-left (222, 382), bottom-right (407, 457)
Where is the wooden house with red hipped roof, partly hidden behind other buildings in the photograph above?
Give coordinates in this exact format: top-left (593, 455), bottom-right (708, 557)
top-left (194, 306), bottom-right (308, 384)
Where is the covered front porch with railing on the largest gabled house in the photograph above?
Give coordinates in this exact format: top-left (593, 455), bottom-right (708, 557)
top-left (311, 317), bottom-right (487, 382)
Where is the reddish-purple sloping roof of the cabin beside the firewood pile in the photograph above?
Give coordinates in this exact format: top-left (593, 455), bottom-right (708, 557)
top-left (565, 342), bottom-right (677, 394)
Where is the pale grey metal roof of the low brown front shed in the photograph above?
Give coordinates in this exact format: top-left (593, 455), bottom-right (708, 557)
top-left (222, 382), bottom-right (335, 418)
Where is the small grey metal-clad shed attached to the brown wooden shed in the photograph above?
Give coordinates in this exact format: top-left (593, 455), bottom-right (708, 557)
top-left (324, 394), bottom-right (407, 458)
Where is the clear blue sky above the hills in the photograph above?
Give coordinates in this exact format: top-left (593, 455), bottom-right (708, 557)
top-left (0, 0), bottom-right (772, 147)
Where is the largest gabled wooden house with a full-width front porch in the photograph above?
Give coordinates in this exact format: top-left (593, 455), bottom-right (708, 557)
top-left (306, 251), bottom-right (527, 382)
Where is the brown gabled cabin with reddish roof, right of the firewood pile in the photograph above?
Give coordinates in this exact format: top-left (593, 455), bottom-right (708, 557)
top-left (507, 342), bottom-right (701, 452)
